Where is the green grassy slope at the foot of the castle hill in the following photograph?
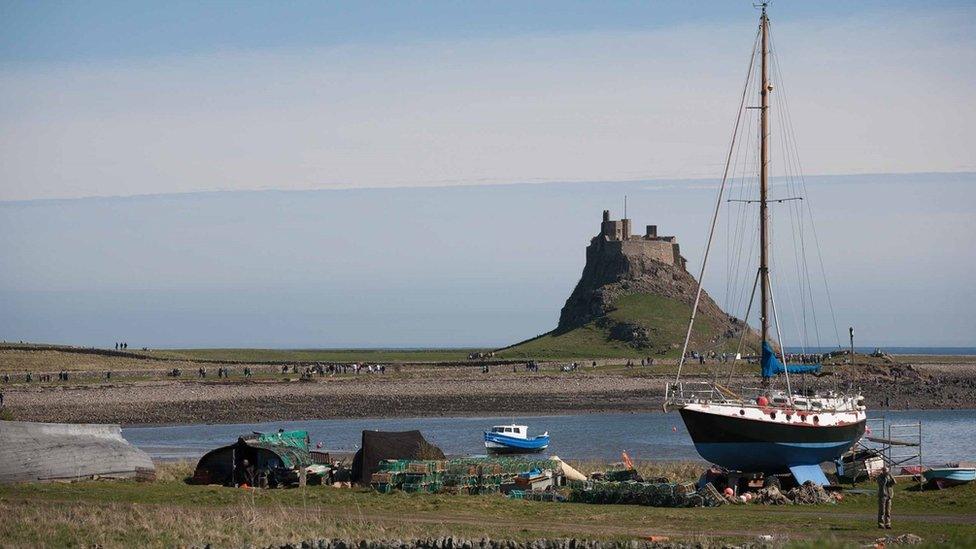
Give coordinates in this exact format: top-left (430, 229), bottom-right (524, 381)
top-left (497, 294), bottom-right (736, 359)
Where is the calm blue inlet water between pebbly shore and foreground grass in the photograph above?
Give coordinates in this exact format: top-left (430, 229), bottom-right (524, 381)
top-left (122, 410), bottom-right (976, 464)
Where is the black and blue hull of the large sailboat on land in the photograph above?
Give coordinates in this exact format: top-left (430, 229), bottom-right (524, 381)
top-left (680, 409), bottom-right (865, 473)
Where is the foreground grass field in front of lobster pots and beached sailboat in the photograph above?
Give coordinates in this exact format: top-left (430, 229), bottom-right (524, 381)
top-left (0, 465), bottom-right (976, 547)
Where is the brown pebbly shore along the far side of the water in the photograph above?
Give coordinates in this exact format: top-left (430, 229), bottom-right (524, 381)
top-left (5, 373), bottom-right (976, 427)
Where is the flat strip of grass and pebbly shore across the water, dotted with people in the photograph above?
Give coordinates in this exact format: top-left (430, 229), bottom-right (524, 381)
top-left (0, 345), bottom-right (976, 425)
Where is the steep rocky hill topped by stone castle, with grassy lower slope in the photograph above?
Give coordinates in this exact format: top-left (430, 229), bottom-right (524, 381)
top-left (501, 212), bottom-right (758, 358)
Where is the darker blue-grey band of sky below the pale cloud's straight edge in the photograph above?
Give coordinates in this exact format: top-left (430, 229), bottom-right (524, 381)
top-left (0, 174), bottom-right (976, 348)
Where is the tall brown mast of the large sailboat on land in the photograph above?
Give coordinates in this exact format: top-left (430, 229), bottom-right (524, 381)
top-left (759, 3), bottom-right (771, 342)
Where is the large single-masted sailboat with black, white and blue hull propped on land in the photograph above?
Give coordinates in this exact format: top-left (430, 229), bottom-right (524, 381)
top-left (665, 3), bottom-right (866, 484)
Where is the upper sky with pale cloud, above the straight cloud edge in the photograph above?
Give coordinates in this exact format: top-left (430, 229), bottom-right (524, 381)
top-left (0, 1), bottom-right (976, 200)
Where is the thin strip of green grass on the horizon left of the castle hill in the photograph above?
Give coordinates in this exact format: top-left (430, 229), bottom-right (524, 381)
top-left (137, 349), bottom-right (473, 362)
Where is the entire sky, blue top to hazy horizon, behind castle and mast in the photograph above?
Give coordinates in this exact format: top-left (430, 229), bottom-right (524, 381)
top-left (0, 0), bottom-right (976, 347)
